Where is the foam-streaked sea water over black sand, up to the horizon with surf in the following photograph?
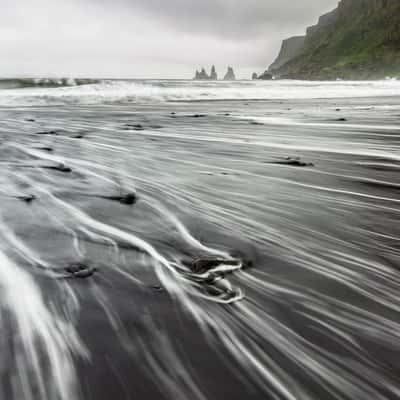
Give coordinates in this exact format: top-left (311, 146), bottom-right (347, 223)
top-left (0, 79), bottom-right (400, 400)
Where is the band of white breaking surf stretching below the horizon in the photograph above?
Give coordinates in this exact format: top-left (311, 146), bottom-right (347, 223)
top-left (0, 79), bottom-right (400, 106)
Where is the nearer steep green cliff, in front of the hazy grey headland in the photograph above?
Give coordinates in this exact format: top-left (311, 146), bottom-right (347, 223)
top-left (271, 0), bottom-right (400, 79)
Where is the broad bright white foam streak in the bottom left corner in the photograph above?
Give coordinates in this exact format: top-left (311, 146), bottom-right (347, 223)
top-left (0, 251), bottom-right (86, 400)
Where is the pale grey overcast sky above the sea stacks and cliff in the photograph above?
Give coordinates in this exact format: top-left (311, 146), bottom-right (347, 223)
top-left (0, 0), bottom-right (338, 78)
